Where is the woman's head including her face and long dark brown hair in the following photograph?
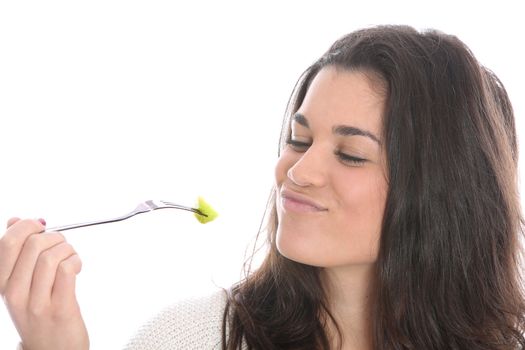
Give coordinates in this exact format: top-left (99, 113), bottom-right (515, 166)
top-left (226, 26), bottom-right (525, 349)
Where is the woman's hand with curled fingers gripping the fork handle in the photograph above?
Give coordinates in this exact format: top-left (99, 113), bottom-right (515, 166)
top-left (0, 218), bottom-right (89, 350)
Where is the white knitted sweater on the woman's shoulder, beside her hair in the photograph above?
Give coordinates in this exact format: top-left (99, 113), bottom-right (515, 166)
top-left (125, 290), bottom-right (226, 350)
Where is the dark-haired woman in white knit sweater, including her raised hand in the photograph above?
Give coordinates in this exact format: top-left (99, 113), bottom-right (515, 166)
top-left (0, 26), bottom-right (525, 350)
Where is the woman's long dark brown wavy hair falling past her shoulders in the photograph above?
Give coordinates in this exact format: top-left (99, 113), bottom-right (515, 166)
top-left (222, 26), bottom-right (525, 350)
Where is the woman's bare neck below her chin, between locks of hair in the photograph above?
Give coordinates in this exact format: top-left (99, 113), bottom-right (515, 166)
top-left (322, 264), bottom-right (374, 350)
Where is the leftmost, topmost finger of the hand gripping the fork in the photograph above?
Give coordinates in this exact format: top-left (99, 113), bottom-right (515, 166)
top-left (0, 218), bottom-right (45, 294)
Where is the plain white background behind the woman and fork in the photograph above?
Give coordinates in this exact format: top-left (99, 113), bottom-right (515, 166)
top-left (0, 0), bottom-right (525, 350)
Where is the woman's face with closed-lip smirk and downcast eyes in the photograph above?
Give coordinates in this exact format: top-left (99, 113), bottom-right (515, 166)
top-left (275, 66), bottom-right (387, 267)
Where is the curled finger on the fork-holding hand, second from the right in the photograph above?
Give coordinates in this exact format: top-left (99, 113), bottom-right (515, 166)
top-left (29, 241), bottom-right (76, 308)
